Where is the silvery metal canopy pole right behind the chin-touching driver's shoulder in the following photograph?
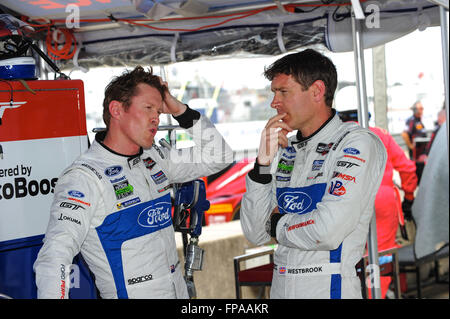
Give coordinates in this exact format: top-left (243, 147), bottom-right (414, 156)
top-left (352, 11), bottom-right (381, 299)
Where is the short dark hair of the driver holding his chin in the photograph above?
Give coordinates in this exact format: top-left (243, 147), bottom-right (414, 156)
top-left (264, 49), bottom-right (337, 107)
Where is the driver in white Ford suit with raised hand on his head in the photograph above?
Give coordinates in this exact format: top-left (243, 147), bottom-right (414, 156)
top-left (34, 67), bottom-right (232, 298)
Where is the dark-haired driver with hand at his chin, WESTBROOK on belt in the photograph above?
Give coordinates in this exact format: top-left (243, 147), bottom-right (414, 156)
top-left (241, 49), bottom-right (386, 299)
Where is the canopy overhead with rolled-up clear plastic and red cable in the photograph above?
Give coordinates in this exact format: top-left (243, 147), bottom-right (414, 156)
top-left (2, 0), bottom-right (439, 68)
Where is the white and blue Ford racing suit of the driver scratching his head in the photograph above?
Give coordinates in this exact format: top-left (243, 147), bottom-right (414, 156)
top-left (34, 109), bottom-right (232, 298)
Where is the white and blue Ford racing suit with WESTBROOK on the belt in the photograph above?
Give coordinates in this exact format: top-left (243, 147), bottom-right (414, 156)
top-left (241, 113), bottom-right (387, 299)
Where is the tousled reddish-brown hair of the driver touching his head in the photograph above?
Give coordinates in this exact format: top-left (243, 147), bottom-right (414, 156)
top-left (103, 66), bottom-right (167, 127)
